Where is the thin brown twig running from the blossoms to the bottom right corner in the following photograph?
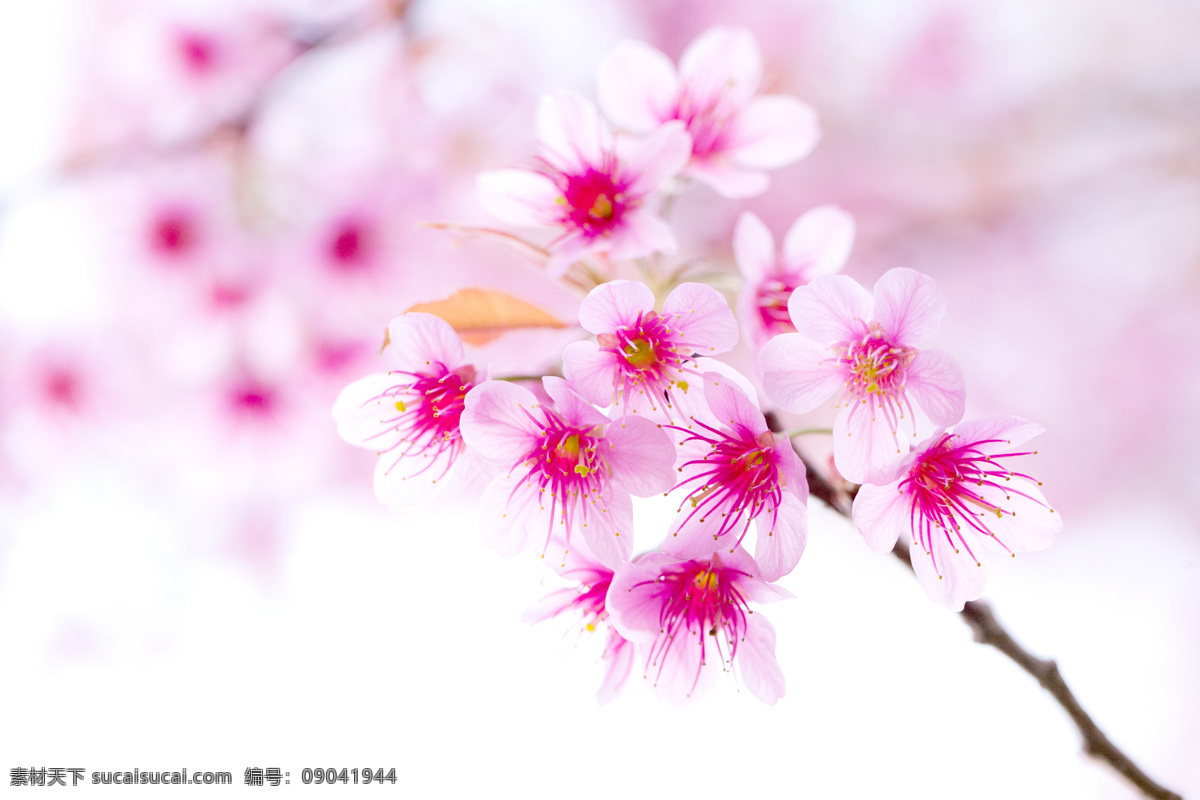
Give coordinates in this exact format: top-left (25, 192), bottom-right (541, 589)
top-left (782, 443), bottom-right (1183, 800)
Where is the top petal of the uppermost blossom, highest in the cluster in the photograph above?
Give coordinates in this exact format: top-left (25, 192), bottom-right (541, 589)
top-left (679, 28), bottom-right (762, 102)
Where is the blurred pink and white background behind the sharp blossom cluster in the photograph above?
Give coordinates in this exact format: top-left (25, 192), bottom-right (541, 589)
top-left (0, 0), bottom-right (1200, 799)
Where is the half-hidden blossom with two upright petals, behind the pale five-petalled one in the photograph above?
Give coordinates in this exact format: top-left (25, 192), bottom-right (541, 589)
top-left (733, 205), bottom-right (854, 347)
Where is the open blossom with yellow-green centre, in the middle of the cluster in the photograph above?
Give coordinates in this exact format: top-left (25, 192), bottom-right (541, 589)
top-left (563, 281), bottom-right (738, 420)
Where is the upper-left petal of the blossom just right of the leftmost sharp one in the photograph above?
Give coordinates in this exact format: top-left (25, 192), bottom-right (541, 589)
top-left (458, 380), bottom-right (541, 467)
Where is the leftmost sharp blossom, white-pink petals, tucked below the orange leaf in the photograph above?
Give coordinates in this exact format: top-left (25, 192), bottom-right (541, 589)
top-left (334, 312), bottom-right (476, 506)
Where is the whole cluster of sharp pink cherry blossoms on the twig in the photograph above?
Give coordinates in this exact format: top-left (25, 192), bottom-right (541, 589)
top-left (334, 29), bottom-right (1060, 703)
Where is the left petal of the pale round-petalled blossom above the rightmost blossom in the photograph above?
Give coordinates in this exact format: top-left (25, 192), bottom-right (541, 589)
top-left (758, 333), bottom-right (844, 414)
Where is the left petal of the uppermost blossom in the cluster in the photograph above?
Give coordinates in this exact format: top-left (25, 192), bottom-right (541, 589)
top-left (596, 40), bottom-right (679, 133)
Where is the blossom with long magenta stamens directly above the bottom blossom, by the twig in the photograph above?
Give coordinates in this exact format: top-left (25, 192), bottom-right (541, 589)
top-left (662, 372), bottom-right (809, 581)
